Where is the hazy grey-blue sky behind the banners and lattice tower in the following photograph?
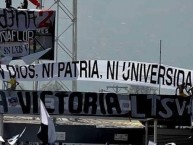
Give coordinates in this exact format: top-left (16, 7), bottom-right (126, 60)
top-left (1, 0), bottom-right (193, 93)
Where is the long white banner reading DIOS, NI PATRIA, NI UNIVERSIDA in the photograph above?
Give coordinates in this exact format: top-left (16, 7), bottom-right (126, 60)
top-left (0, 60), bottom-right (193, 89)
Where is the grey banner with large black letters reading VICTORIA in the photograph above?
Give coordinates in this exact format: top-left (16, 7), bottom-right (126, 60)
top-left (0, 90), bottom-right (129, 117)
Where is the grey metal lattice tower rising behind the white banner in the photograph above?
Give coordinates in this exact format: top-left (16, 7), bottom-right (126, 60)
top-left (40, 0), bottom-right (77, 91)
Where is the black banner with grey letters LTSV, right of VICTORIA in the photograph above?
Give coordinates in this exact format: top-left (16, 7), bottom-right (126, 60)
top-left (130, 94), bottom-right (192, 121)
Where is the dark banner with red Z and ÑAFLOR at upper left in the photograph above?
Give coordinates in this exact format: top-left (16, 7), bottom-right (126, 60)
top-left (0, 9), bottom-right (55, 60)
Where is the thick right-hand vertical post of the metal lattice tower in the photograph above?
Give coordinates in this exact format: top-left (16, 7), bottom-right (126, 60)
top-left (72, 0), bottom-right (77, 91)
